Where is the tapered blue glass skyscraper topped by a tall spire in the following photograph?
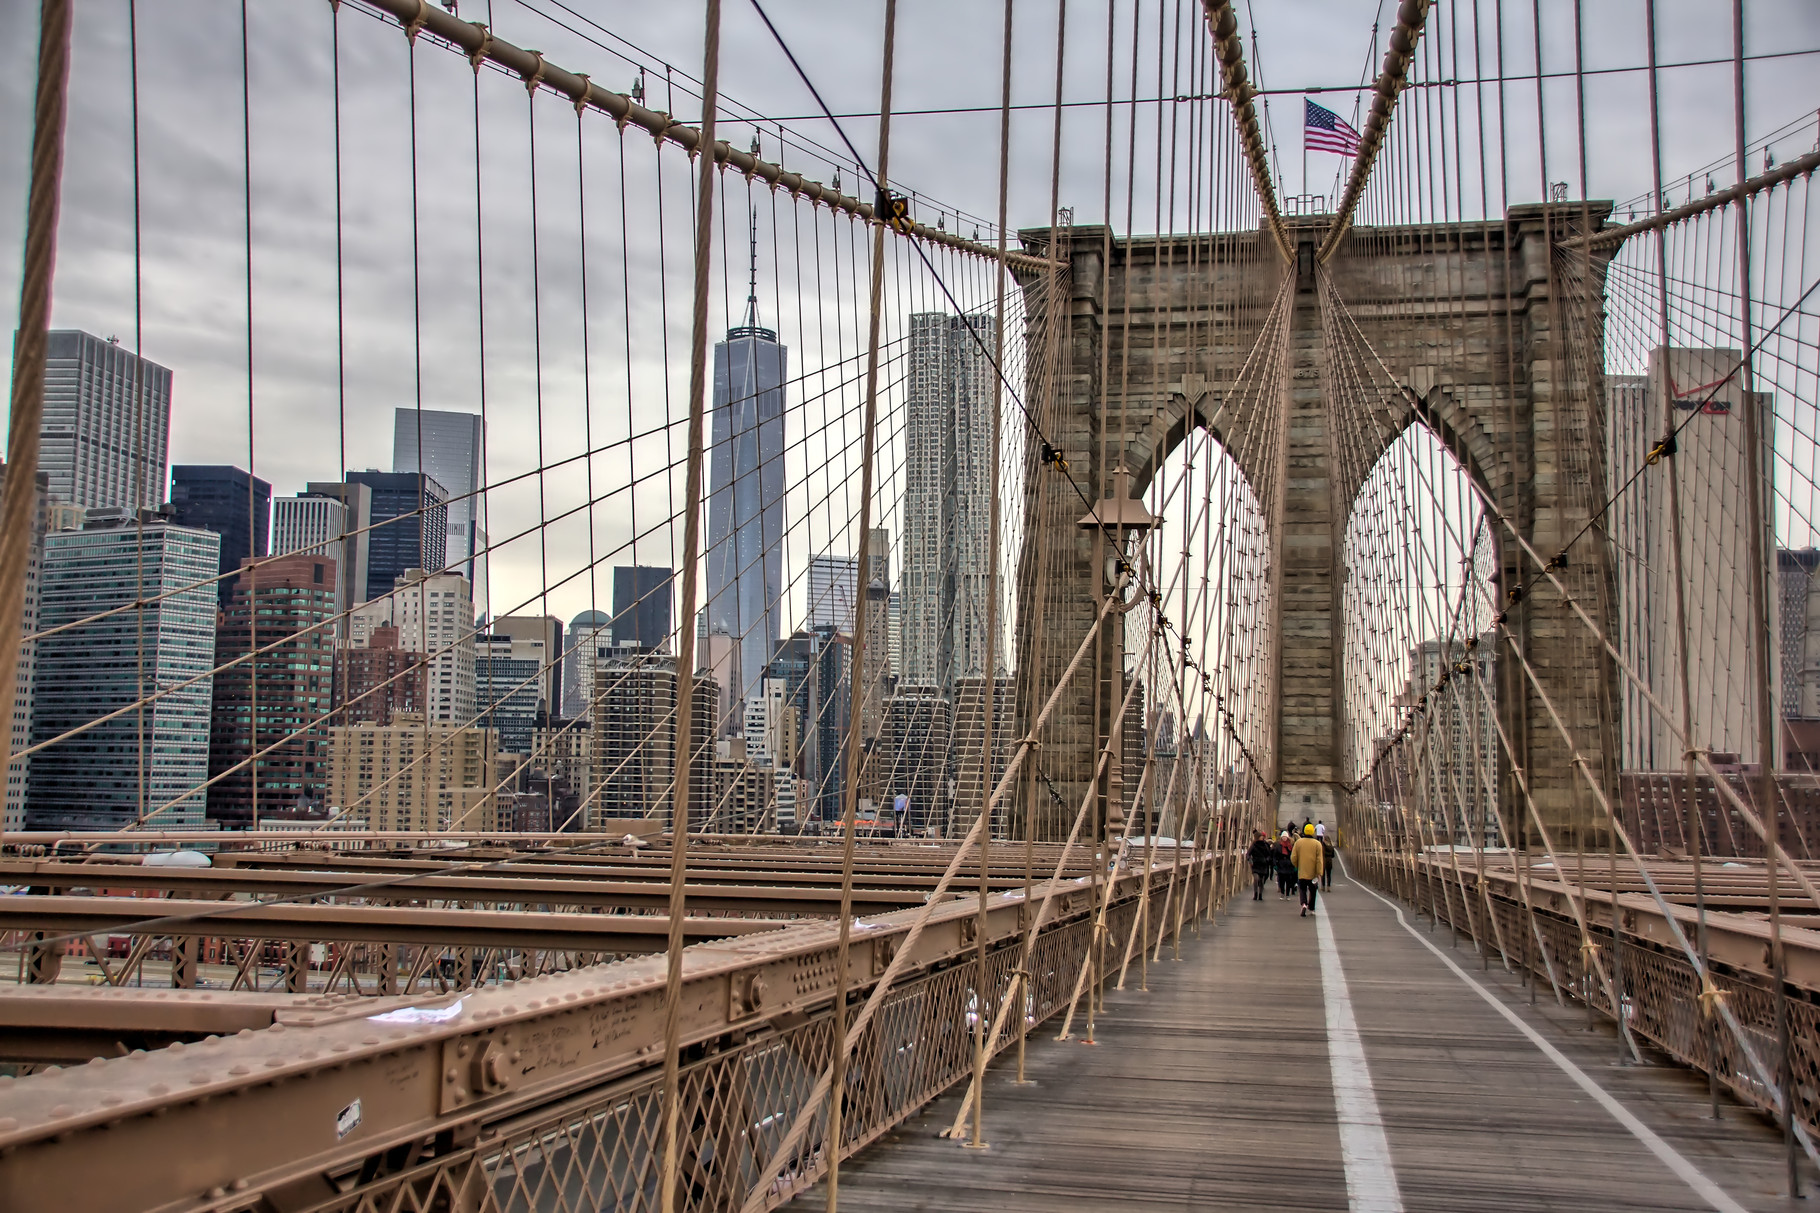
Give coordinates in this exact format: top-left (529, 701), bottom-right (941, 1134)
top-left (706, 271), bottom-right (788, 703)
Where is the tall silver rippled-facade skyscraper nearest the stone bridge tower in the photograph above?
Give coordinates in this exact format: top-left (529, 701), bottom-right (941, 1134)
top-left (899, 311), bottom-right (1003, 699)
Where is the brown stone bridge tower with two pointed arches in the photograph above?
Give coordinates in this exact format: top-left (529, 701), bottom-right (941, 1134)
top-left (1017, 204), bottom-right (1618, 851)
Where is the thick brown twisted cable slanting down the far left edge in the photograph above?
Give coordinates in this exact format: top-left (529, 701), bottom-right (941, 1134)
top-left (0, 0), bottom-right (71, 838)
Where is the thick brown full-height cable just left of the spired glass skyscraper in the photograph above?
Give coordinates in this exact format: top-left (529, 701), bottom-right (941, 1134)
top-left (659, 0), bottom-right (721, 1213)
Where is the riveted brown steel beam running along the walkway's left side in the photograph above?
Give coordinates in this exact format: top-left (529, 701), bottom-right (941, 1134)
top-left (0, 856), bottom-right (1186, 1213)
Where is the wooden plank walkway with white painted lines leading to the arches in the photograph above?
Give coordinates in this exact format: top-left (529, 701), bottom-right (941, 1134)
top-left (794, 863), bottom-right (1815, 1213)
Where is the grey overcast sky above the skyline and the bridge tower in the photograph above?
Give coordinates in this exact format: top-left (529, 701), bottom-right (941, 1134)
top-left (0, 0), bottom-right (1820, 637)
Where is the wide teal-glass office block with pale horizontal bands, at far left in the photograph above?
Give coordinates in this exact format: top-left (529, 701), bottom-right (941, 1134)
top-left (25, 515), bottom-right (220, 829)
